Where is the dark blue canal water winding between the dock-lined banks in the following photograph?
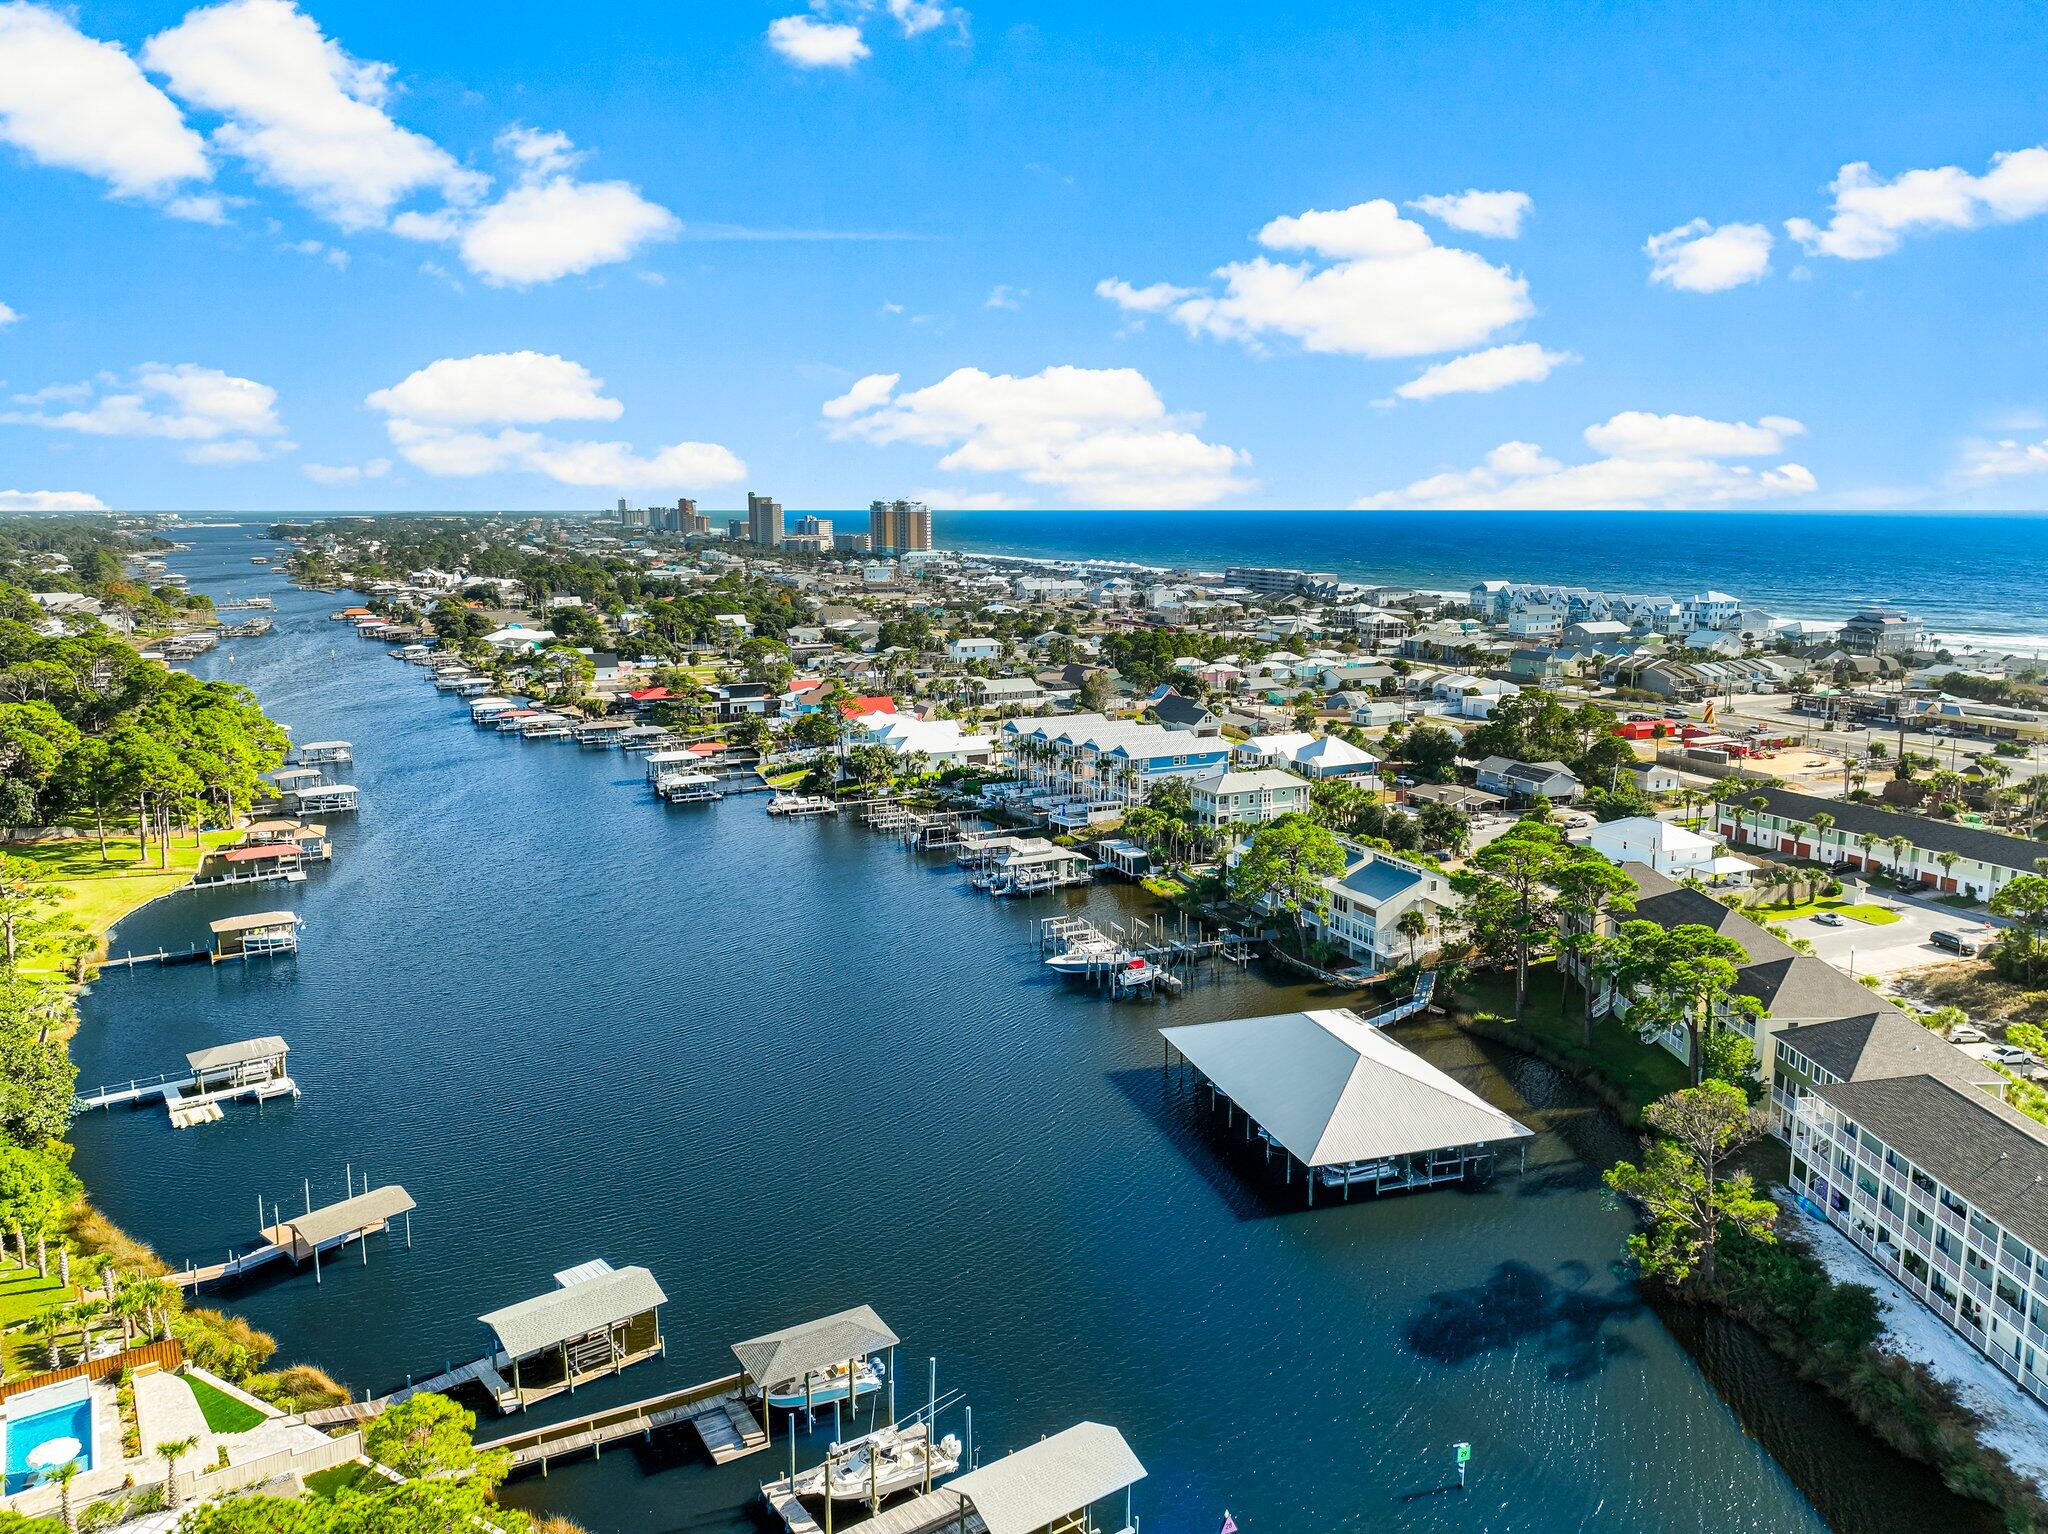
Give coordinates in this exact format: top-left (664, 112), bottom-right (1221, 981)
top-left (76, 528), bottom-right (1989, 1534)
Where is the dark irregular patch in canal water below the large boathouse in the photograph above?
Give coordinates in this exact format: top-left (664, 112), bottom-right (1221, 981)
top-left (1403, 1262), bottom-right (1645, 1382)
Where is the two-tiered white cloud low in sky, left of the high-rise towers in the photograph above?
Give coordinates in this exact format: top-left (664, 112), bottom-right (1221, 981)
top-left (365, 352), bottom-right (745, 492)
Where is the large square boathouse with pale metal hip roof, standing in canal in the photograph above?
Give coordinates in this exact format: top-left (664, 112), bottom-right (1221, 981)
top-left (1159, 1010), bottom-right (1534, 1204)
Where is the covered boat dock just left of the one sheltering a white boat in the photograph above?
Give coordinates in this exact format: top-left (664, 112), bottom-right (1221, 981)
top-left (477, 1258), bottom-right (668, 1411)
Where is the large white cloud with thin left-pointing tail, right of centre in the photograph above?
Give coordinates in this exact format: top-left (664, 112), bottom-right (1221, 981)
top-left (1096, 199), bottom-right (1534, 356)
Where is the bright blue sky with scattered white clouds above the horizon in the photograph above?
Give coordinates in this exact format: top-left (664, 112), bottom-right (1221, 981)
top-left (0, 0), bottom-right (2048, 510)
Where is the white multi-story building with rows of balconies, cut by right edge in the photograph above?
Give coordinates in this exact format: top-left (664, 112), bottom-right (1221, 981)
top-left (1792, 1075), bottom-right (2048, 1405)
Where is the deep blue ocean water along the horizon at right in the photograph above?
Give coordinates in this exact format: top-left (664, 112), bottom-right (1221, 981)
top-left (932, 512), bottom-right (2048, 643)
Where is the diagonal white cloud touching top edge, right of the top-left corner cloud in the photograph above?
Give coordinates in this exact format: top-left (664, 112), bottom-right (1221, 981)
top-left (141, 0), bottom-right (485, 229)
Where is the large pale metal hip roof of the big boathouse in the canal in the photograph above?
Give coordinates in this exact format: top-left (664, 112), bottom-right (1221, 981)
top-left (1159, 1012), bottom-right (1534, 1167)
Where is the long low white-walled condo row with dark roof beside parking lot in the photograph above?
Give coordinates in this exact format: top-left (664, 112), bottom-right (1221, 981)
top-left (1720, 789), bottom-right (2048, 899)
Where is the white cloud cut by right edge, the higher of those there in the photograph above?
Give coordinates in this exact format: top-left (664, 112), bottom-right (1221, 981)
top-left (1786, 145), bottom-right (2048, 260)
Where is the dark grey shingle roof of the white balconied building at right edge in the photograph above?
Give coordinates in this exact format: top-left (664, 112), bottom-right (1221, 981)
top-left (1815, 1075), bottom-right (2048, 1251)
